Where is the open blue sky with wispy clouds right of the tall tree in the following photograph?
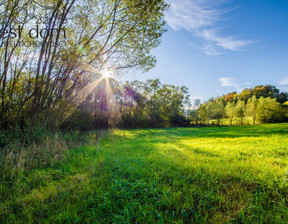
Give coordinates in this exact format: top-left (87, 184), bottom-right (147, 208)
top-left (124, 0), bottom-right (288, 101)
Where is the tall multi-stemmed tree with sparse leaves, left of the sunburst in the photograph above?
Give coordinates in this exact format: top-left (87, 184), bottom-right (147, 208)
top-left (0, 0), bottom-right (168, 130)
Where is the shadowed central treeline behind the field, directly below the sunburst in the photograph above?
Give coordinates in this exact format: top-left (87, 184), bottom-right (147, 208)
top-left (61, 79), bottom-right (190, 130)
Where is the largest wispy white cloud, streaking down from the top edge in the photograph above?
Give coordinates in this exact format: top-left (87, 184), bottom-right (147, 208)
top-left (165, 0), bottom-right (254, 56)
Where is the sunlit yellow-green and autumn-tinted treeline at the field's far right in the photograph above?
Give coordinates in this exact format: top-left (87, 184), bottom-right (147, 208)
top-left (189, 85), bottom-right (288, 125)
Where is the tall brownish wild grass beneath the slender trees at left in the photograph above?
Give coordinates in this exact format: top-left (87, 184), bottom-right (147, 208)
top-left (0, 130), bottom-right (95, 178)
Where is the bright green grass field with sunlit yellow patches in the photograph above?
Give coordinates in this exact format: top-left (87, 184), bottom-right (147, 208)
top-left (0, 124), bottom-right (288, 224)
